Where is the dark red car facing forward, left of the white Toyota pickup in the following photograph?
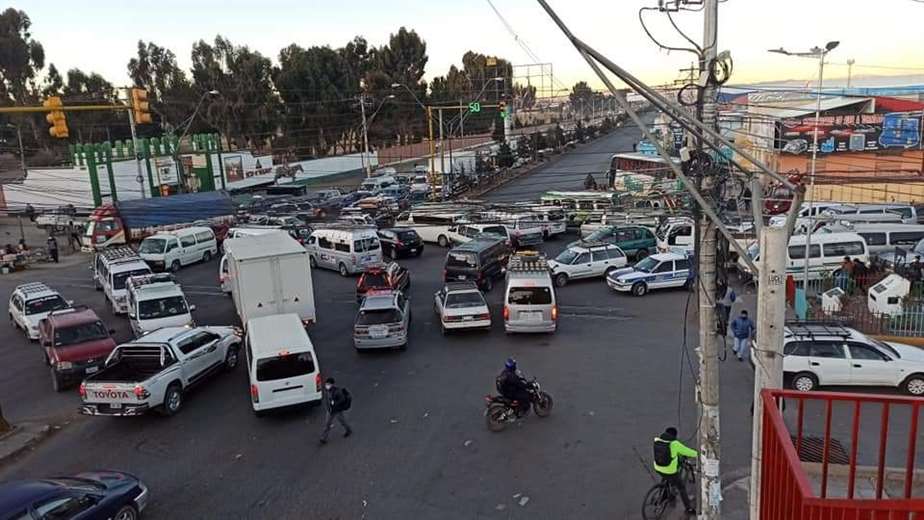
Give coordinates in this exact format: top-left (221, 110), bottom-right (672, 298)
top-left (39, 307), bottom-right (116, 392)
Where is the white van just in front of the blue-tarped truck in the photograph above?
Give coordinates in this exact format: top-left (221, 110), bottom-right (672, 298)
top-left (138, 227), bottom-right (218, 272)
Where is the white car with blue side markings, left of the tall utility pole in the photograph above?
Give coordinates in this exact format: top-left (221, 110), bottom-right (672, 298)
top-left (606, 253), bottom-right (692, 296)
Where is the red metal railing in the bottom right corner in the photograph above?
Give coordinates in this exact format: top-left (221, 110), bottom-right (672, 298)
top-left (760, 390), bottom-right (924, 520)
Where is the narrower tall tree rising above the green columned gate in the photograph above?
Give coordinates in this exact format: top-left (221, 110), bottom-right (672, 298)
top-left (128, 40), bottom-right (199, 132)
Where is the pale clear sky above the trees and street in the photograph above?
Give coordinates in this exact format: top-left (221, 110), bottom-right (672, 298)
top-left (7, 0), bottom-right (924, 93)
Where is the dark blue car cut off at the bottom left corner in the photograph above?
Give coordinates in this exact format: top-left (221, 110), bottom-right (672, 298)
top-left (0, 470), bottom-right (148, 520)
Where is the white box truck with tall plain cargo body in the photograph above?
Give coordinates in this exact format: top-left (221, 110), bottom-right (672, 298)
top-left (224, 233), bottom-right (315, 326)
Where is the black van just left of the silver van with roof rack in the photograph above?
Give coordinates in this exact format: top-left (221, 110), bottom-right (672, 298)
top-left (443, 235), bottom-right (510, 291)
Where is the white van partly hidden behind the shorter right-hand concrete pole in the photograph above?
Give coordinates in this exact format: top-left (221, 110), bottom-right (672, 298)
top-left (738, 232), bottom-right (869, 281)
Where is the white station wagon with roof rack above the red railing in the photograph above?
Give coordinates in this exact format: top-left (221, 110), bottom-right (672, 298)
top-left (783, 324), bottom-right (924, 396)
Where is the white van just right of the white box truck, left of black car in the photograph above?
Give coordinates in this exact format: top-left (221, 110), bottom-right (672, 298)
top-left (305, 226), bottom-right (382, 276)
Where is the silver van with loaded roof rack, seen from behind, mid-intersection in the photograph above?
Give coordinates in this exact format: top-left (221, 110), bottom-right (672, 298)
top-left (504, 252), bottom-right (558, 333)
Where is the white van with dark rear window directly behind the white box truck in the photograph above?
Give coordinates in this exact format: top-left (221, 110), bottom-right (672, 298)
top-left (244, 314), bottom-right (322, 415)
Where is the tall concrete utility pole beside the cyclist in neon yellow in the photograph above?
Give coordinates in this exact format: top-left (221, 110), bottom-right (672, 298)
top-left (697, 0), bottom-right (722, 520)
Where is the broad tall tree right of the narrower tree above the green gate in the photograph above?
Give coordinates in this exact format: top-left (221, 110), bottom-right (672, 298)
top-left (192, 35), bottom-right (280, 147)
